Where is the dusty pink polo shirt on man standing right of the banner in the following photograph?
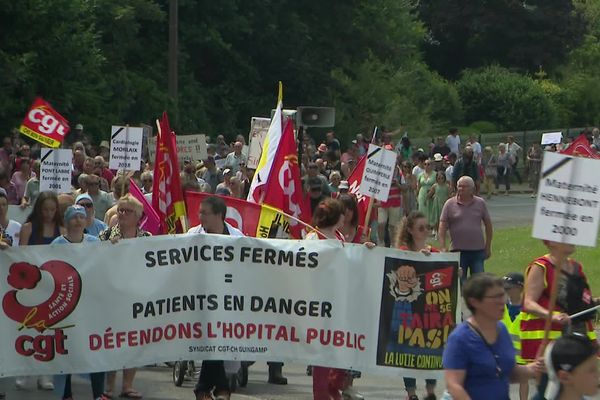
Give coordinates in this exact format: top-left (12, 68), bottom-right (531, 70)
top-left (440, 196), bottom-right (490, 250)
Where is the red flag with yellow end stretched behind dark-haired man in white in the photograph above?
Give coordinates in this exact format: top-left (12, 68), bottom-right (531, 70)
top-left (185, 192), bottom-right (288, 238)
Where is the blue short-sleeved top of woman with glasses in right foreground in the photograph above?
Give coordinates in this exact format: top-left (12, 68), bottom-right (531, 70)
top-left (442, 321), bottom-right (515, 400)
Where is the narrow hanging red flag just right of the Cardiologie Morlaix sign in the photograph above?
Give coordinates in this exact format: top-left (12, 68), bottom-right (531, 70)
top-left (152, 112), bottom-right (185, 233)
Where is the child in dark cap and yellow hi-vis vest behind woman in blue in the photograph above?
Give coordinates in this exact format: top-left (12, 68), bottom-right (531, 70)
top-left (502, 272), bottom-right (529, 400)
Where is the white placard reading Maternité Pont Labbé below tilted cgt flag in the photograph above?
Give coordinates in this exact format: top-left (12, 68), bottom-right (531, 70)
top-left (40, 148), bottom-right (73, 193)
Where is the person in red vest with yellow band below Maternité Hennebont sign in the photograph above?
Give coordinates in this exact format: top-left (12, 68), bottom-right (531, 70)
top-left (520, 240), bottom-right (596, 399)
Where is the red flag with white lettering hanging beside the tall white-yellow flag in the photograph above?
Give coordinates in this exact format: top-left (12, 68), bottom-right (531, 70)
top-left (263, 119), bottom-right (311, 239)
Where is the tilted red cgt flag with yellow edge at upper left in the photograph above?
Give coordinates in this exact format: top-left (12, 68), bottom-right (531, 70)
top-left (19, 97), bottom-right (69, 148)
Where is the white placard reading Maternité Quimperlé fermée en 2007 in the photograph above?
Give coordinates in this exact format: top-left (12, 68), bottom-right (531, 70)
top-left (359, 144), bottom-right (396, 201)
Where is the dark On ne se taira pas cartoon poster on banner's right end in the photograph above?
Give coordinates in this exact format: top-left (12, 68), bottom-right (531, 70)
top-left (377, 257), bottom-right (459, 370)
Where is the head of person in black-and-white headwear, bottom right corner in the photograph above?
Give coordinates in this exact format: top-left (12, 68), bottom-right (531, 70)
top-left (544, 333), bottom-right (600, 400)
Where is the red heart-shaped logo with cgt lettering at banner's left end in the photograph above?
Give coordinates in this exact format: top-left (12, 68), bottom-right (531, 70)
top-left (2, 260), bottom-right (81, 362)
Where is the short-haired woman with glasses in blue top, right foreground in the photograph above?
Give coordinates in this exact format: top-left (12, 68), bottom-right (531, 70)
top-left (442, 272), bottom-right (542, 400)
